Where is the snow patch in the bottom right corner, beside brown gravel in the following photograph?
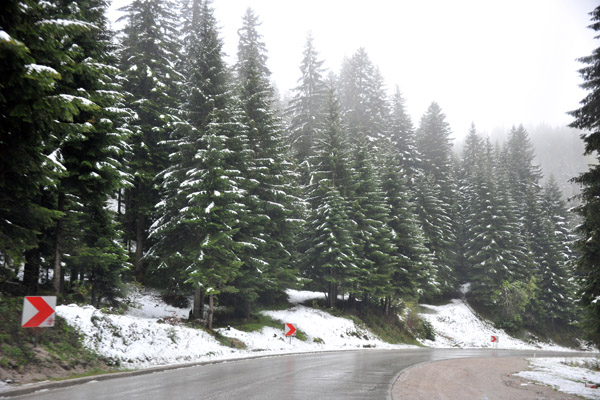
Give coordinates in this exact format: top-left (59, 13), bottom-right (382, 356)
top-left (516, 358), bottom-right (600, 399)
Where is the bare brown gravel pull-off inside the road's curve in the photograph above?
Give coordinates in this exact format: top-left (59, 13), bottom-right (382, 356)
top-left (392, 358), bottom-right (580, 400)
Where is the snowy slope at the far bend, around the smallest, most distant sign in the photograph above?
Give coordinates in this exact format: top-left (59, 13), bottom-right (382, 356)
top-left (419, 299), bottom-right (573, 351)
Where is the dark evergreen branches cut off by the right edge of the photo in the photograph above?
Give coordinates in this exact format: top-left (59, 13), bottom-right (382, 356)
top-left (570, 7), bottom-right (600, 342)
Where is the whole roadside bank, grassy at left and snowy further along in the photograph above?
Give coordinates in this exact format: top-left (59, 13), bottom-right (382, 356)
top-left (0, 288), bottom-right (592, 387)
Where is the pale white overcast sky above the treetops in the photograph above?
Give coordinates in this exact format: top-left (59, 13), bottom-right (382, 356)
top-left (110, 0), bottom-right (598, 137)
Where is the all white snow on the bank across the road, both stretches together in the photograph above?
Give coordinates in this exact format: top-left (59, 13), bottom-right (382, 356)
top-left (57, 289), bottom-right (580, 368)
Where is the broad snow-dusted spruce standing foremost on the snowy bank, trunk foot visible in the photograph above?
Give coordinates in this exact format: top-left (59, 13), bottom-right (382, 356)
top-left (148, 0), bottom-right (246, 322)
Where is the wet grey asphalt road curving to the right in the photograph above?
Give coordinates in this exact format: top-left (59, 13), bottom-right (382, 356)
top-left (0, 349), bottom-right (576, 400)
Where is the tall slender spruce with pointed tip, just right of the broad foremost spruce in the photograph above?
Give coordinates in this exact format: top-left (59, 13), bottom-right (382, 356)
top-left (235, 9), bottom-right (295, 316)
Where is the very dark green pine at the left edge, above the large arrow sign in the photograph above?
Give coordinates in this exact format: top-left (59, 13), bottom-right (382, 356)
top-left (0, 1), bottom-right (66, 276)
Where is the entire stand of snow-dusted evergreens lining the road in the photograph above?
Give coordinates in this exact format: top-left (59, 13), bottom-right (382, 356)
top-left (0, 0), bottom-right (600, 341)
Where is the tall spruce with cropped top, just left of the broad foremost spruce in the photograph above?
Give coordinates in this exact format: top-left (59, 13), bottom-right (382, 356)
top-left (120, 0), bottom-right (183, 281)
